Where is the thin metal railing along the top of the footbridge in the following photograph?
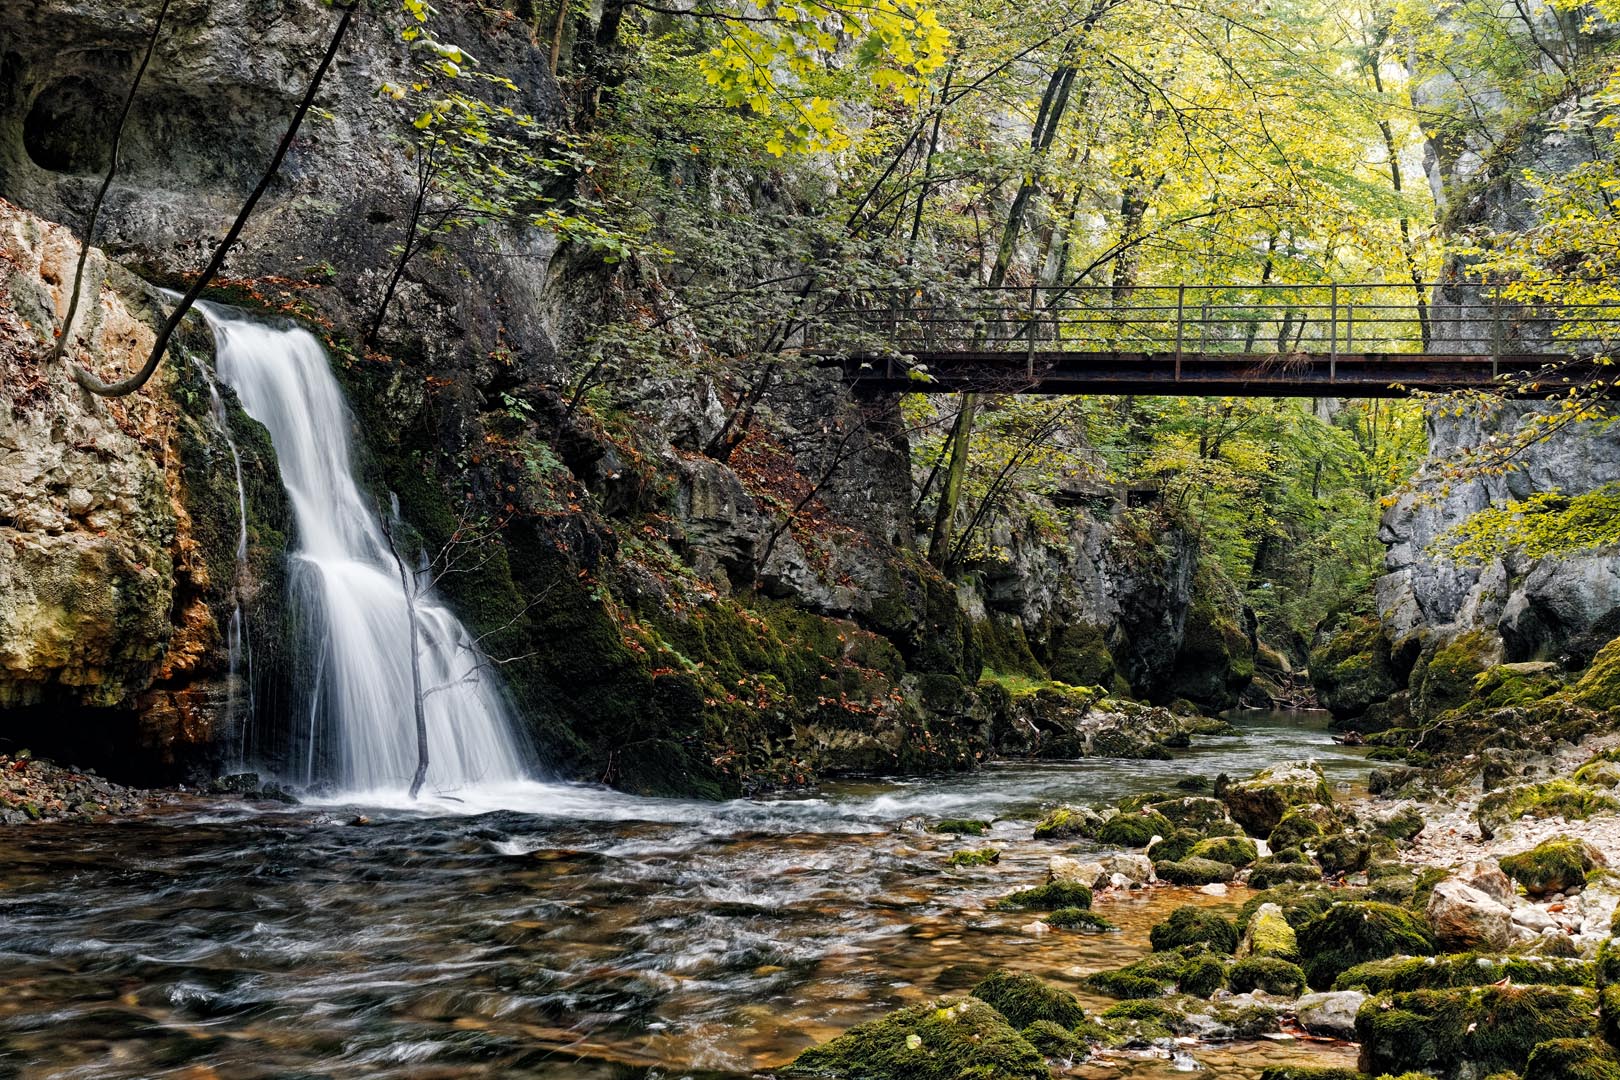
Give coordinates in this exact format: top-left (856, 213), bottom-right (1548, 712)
top-left (807, 282), bottom-right (1620, 359)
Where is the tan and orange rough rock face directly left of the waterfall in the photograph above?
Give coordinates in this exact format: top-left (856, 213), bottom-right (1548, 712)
top-left (0, 202), bottom-right (285, 777)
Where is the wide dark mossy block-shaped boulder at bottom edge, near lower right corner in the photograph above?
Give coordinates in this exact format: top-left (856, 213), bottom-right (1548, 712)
top-left (1356, 986), bottom-right (1597, 1078)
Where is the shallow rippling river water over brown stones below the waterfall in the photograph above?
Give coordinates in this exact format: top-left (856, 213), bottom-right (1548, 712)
top-left (0, 714), bottom-right (1366, 1080)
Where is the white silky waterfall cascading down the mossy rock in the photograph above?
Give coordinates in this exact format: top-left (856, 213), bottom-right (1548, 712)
top-left (199, 304), bottom-right (527, 793)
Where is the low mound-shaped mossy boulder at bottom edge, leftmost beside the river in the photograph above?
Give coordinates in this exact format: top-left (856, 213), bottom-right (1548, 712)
top-left (786, 997), bottom-right (1051, 1080)
